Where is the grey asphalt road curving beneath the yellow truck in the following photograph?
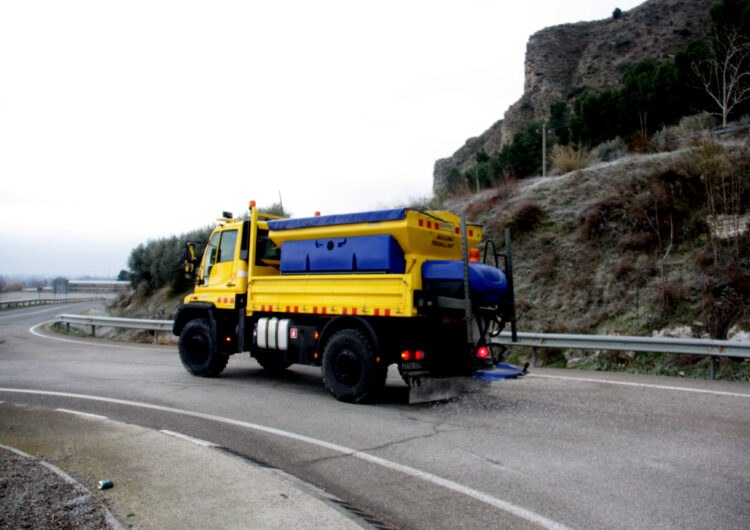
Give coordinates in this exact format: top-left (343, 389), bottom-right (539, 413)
top-left (0, 304), bottom-right (750, 528)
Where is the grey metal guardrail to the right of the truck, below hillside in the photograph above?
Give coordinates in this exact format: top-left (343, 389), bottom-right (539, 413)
top-left (490, 332), bottom-right (750, 379)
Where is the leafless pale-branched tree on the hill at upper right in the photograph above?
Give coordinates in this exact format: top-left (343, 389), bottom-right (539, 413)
top-left (692, 27), bottom-right (750, 127)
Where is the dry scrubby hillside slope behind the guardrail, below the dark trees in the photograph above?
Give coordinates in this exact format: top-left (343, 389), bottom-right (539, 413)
top-left (445, 128), bottom-right (750, 376)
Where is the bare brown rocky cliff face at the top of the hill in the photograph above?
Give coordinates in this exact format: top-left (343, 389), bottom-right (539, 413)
top-left (433, 0), bottom-right (714, 195)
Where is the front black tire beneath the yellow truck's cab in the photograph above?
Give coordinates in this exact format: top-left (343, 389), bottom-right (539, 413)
top-left (178, 319), bottom-right (229, 377)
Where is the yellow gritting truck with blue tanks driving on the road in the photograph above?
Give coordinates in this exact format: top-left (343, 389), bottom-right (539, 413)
top-left (173, 202), bottom-right (515, 402)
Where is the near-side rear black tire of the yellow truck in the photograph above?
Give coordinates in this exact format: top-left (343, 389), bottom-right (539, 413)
top-left (322, 329), bottom-right (386, 403)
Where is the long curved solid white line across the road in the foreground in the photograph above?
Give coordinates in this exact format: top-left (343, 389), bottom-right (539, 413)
top-left (0, 388), bottom-right (567, 530)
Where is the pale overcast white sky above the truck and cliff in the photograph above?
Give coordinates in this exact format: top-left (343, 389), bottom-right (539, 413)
top-left (0, 0), bottom-right (640, 277)
